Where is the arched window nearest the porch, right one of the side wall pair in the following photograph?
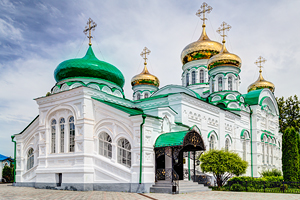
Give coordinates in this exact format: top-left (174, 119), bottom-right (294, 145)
top-left (118, 138), bottom-right (131, 167)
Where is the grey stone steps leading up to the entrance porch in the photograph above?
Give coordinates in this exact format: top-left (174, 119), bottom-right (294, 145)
top-left (150, 180), bottom-right (211, 194)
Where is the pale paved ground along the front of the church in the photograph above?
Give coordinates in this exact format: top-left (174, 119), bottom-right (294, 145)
top-left (0, 184), bottom-right (300, 200)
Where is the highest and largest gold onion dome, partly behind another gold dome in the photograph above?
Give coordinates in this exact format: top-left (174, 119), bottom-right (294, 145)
top-left (181, 24), bottom-right (222, 64)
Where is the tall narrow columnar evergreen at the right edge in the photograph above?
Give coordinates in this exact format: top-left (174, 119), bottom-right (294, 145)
top-left (282, 127), bottom-right (299, 182)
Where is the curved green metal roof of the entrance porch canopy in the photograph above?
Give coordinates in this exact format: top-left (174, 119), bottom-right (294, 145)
top-left (154, 130), bottom-right (189, 147)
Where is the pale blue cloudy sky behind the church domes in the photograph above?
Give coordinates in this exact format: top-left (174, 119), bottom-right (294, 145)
top-left (0, 0), bottom-right (300, 156)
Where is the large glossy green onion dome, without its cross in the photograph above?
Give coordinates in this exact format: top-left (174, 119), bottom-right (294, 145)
top-left (54, 46), bottom-right (125, 88)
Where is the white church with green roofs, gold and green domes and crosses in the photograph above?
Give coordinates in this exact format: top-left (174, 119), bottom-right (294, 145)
top-left (12, 3), bottom-right (282, 192)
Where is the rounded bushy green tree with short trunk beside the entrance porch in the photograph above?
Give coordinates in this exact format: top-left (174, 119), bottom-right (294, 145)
top-left (200, 150), bottom-right (248, 187)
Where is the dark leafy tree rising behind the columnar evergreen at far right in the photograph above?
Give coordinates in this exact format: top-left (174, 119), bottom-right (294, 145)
top-left (276, 95), bottom-right (300, 133)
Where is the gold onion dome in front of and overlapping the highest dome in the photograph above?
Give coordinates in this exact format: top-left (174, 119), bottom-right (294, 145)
top-left (207, 40), bottom-right (242, 70)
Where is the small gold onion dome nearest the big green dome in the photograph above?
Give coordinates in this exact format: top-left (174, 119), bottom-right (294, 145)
top-left (131, 62), bottom-right (159, 87)
